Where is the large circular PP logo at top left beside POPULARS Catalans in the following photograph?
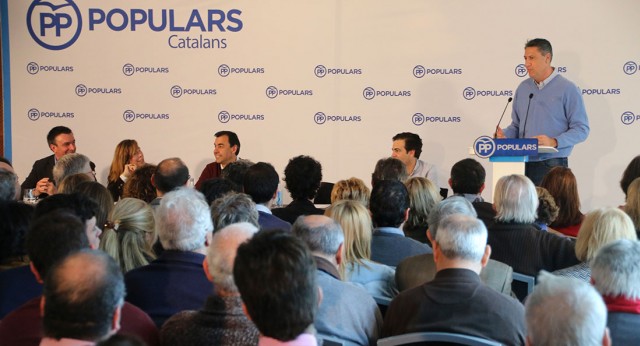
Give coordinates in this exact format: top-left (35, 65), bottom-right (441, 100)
top-left (27, 0), bottom-right (82, 50)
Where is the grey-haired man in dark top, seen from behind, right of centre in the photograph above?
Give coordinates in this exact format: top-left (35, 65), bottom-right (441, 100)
top-left (383, 214), bottom-right (525, 345)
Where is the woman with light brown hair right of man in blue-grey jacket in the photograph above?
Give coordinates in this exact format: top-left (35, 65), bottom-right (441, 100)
top-left (402, 177), bottom-right (442, 244)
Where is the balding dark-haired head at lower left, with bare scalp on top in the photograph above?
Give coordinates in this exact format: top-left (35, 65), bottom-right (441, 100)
top-left (42, 250), bottom-right (125, 341)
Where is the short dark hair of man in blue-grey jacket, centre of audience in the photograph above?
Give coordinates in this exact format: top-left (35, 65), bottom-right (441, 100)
top-left (369, 180), bottom-right (409, 227)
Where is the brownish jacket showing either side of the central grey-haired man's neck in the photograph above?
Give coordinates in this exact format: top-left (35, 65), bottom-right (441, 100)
top-left (396, 254), bottom-right (513, 295)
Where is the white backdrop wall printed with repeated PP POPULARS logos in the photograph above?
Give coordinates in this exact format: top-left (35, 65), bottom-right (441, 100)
top-left (2, 0), bottom-right (640, 210)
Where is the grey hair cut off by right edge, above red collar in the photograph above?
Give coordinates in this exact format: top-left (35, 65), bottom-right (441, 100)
top-left (590, 239), bottom-right (640, 300)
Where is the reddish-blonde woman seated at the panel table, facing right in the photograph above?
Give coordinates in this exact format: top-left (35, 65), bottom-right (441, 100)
top-left (107, 139), bottom-right (144, 201)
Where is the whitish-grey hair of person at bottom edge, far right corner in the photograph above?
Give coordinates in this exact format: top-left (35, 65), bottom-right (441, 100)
top-left (525, 271), bottom-right (607, 346)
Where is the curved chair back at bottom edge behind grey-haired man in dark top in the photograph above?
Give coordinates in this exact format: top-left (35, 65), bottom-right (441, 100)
top-left (378, 332), bottom-right (501, 346)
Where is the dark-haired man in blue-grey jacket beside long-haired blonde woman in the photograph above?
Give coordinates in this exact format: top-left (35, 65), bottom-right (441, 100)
top-left (369, 180), bottom-right (432, 267)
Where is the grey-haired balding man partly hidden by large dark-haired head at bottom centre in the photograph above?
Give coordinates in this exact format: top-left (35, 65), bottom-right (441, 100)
top-left (160, 222), bottom-right (258, 346)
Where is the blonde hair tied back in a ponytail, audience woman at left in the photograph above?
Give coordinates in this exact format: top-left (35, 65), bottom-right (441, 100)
top-left (100, 198), bottom-right (156, 273)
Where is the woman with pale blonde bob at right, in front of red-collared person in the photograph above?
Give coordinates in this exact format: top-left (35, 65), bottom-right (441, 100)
top-left (553, 208), bottom-right (638, 282)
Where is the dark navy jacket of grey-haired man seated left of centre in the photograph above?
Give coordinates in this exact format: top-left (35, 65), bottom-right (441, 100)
top-left (124, 250), bottom-right (213, 328)
